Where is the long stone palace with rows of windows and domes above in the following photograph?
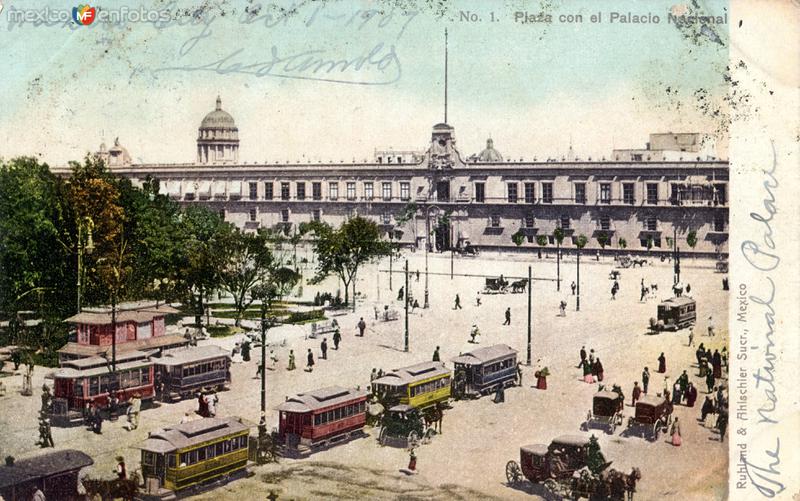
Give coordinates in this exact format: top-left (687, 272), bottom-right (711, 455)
top-left (73, 98), bottom-right (729, 256)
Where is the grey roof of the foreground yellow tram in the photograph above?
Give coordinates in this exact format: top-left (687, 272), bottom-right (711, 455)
top-left (140, 416), bottom-right (249, 454)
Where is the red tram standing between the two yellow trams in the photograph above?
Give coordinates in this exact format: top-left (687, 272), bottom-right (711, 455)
top-left (278, 386), bottom-right (367, 456)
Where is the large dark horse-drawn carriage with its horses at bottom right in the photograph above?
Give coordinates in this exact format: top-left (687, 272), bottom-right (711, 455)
top-left (506, 435), bottom-right (641, 501)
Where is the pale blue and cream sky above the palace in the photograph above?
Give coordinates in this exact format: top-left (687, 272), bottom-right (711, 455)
top-left (0, 0), bottom-right (728, 165)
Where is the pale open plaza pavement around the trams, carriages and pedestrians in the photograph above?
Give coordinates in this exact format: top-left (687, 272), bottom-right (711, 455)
top-left (0, 252), bottom-right (729, 500)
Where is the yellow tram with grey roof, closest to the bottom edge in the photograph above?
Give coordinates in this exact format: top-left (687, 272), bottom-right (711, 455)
top-left (141, 417), bottom-right (250, 497)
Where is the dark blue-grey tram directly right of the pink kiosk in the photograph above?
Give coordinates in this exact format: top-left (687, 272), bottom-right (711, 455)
top-left (151, 345), bottom-right (231, 400)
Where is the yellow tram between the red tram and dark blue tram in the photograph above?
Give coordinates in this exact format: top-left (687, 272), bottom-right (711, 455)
top-left (372, 362), bottom-right (452, 409)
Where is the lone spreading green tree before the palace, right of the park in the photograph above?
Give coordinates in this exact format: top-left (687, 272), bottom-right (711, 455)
top-left (309, 217), bottom-right (390, 304)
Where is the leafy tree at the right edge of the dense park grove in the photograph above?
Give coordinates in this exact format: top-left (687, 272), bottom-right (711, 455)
top-left (219, 229), bottom-right (273, 326)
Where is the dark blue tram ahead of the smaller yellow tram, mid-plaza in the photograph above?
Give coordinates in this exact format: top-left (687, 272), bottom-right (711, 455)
top-left (452, 344), bottom-right (518, 399)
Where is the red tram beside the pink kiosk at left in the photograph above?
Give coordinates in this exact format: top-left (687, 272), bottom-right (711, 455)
top-left (51, 350), bottom-right (155, 425)
